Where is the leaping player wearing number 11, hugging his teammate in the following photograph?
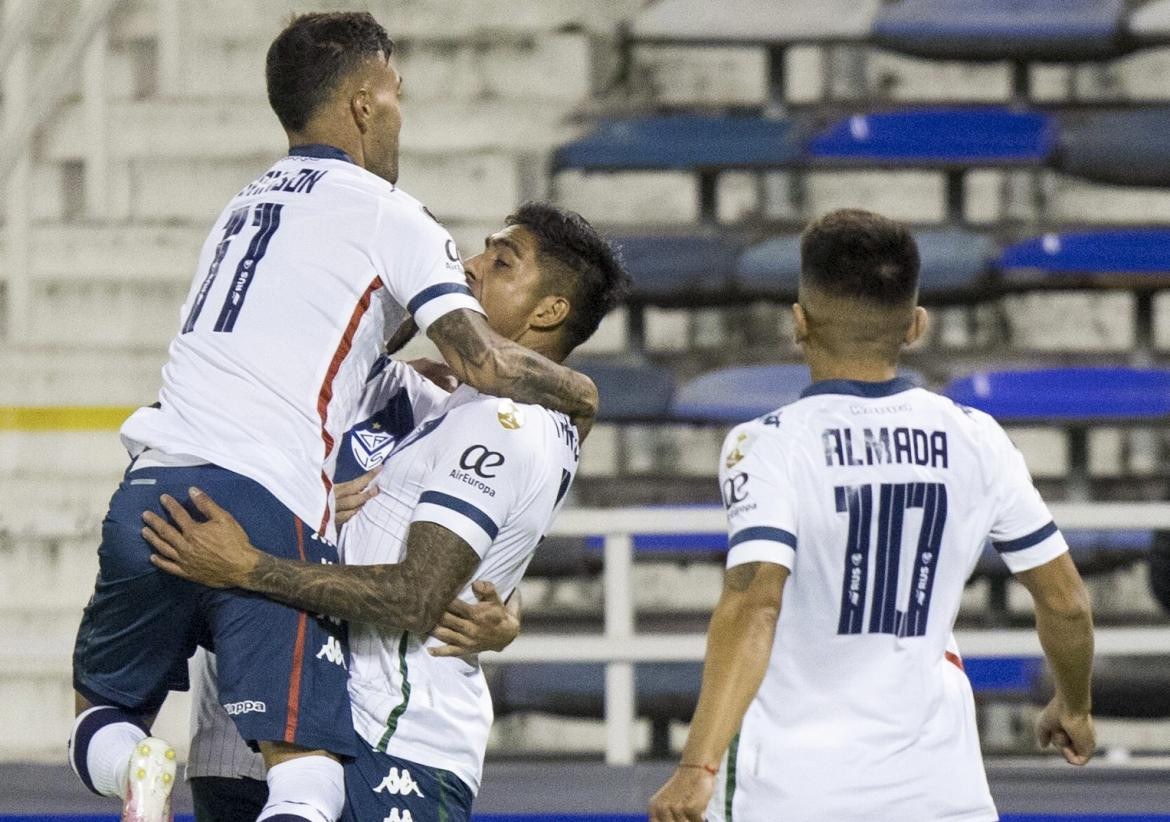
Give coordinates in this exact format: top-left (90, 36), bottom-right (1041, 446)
top-left (70, 13), bottom-right (597, 818)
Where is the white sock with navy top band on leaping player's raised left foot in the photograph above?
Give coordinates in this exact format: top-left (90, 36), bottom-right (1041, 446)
top-left (69, 705), bottom-right (146, 800)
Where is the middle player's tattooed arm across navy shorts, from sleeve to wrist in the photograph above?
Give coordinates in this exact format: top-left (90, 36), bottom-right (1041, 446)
top-left (247, 523), bottom-right (480, 634)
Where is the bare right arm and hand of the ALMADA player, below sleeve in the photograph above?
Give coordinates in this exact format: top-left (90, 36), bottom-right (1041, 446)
top-left (1016, 553), bottom-right (1096, 765)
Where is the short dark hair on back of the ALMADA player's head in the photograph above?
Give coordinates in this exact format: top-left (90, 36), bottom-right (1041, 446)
top-left (800, 208), bottom-right (918, 306)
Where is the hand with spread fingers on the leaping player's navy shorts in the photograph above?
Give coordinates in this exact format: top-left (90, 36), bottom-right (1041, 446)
top-left (143, 488), bottom-right (260, 588)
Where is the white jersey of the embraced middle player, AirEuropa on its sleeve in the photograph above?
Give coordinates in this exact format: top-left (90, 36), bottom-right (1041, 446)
top-left (340, 366), bottom-right (580, 792)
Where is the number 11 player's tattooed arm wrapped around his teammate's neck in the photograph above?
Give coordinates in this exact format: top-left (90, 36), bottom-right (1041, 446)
top-left (427, 309), bottom-right (598, 436)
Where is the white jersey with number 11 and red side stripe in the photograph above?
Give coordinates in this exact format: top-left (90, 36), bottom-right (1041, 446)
top-left (122, 146), bottom-right (481, 536)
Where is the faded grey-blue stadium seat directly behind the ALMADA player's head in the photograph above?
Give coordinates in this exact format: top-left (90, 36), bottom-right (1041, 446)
top-left (736, 228), bottom-right (996, 301)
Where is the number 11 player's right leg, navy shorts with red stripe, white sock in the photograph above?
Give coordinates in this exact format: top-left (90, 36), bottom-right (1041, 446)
top-left (200, 477), bottom-right (353, 822)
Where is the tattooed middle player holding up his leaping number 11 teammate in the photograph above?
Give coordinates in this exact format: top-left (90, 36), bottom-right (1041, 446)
top-left (144, 205), bottom-right (627, 822)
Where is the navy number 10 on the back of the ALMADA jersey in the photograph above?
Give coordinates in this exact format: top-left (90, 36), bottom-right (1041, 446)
top-left (834, 483), bottom-right (947, 636)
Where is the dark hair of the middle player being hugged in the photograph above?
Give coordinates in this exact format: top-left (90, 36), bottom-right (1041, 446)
top-left (504, 202), bottom-right (631, 354)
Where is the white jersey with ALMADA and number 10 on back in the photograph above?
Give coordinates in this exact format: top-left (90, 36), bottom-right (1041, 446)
top-left (710, 380), bottom-right (1067, 822)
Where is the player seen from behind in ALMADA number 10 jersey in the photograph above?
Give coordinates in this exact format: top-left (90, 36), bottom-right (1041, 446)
top-left (651, 210), bottom-right (1094, 822)
